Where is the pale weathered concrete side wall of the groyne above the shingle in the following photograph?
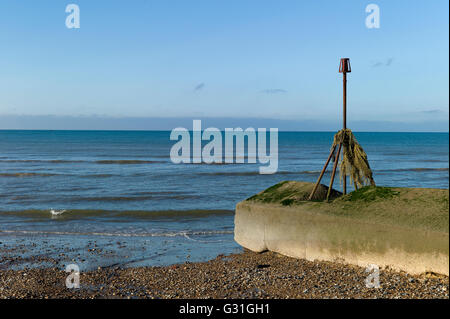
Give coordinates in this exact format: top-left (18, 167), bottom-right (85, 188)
top-left (235, 184), bottom-right (449, 276)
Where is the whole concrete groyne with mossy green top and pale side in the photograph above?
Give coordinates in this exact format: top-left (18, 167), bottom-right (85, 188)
top-left (235, 182), bottom-right (449, 275)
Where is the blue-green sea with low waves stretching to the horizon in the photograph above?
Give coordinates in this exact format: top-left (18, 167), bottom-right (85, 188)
top-left (0, 131), bottom-right (449, 267)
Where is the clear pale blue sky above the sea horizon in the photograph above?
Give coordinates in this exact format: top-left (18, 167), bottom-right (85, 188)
top-left (0, 0), bottom-right (449, 131)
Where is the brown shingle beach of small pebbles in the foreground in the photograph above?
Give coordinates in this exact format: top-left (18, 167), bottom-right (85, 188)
top-left (0, 250), bottom-right (449, 299)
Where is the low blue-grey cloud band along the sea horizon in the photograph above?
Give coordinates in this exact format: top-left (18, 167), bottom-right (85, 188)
top-left (0, 113), bottom-right (449, 133)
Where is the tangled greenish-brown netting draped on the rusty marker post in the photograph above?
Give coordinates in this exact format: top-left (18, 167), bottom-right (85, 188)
top-left (332, 129), bottom-right (375, 187)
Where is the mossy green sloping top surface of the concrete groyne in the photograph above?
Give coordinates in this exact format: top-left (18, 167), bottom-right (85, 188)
top-left (247, 181), bottom-right (449, 233)
